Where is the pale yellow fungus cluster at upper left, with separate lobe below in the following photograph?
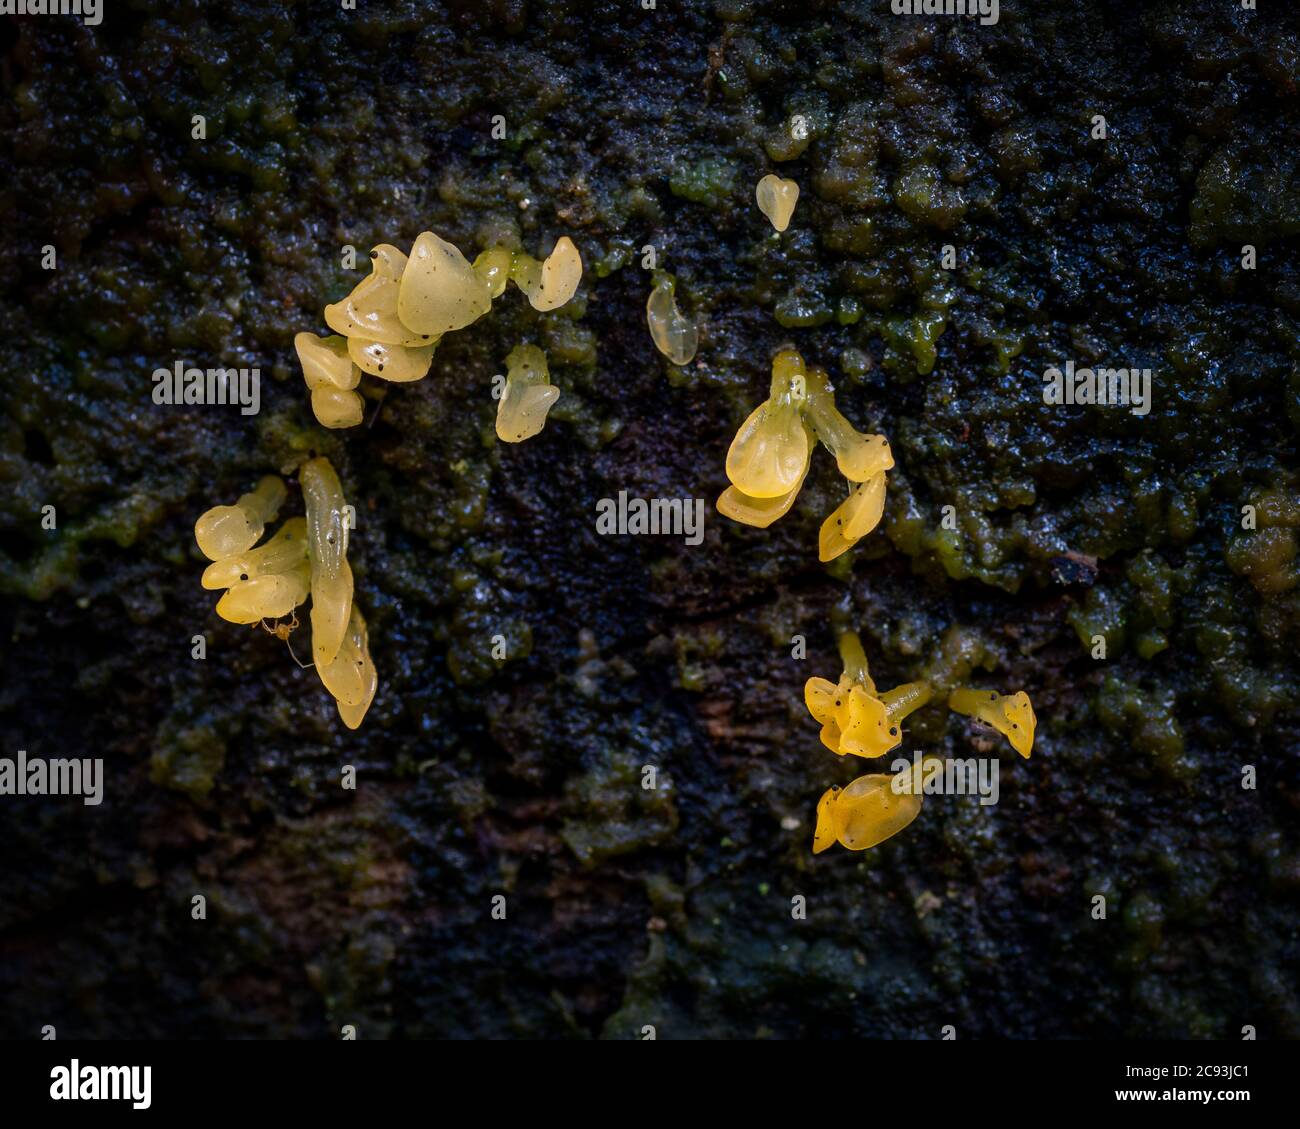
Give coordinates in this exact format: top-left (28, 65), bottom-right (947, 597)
top-left (294, 232), bottom-right (582, 442)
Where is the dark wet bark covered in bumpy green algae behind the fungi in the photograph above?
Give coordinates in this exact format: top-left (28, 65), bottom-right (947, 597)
top-left (0, 0), bottom-right (1300, 1038)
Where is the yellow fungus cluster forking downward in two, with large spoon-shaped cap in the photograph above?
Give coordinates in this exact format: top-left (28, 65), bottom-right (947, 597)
top-left (718, 347), bottom-right (893, 561)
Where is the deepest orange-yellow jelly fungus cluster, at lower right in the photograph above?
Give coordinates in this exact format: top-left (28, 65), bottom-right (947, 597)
top-left (803, 631), bottom-right (1036, 855)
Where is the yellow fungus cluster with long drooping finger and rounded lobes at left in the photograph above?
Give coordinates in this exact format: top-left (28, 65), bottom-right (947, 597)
top-left (194, 458), bottom-right (378, 730)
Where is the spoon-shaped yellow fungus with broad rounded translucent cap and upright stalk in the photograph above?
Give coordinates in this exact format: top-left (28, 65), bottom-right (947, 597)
top-left (727, 350), bottom-right (811, 498)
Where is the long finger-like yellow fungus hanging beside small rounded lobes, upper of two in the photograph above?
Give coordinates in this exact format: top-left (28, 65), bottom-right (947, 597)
top-left (298, 458), bottom-right (352, 666)
